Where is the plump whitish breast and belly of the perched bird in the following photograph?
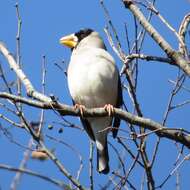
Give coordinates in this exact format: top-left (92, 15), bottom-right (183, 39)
top-left (68, 47), bottom-right (118, 107)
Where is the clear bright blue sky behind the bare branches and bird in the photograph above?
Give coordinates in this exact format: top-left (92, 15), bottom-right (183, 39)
top-left (0, 0), bottom-right (190, 190)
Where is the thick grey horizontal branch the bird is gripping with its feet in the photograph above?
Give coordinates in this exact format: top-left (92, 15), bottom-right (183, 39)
top-left (0, 93), bottom-right (190, 148)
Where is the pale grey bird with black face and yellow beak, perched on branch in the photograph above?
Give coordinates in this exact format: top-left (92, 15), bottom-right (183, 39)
top-left (60, 28), bottom-right (123, 174)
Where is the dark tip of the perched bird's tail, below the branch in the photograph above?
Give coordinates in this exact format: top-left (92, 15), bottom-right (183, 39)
top-left (97, 142), bottom-right (110, 174)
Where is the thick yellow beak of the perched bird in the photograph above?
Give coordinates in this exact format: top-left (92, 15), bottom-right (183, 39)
top-left (59, 34), bottom-right (78, 48)
